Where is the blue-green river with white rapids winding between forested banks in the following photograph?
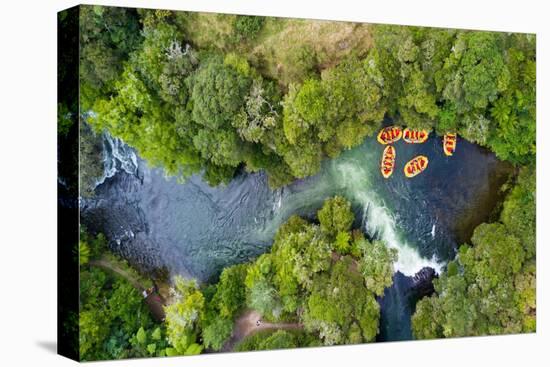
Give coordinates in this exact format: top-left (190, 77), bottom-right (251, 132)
top-left (81, 129), bottom-right (511, 341)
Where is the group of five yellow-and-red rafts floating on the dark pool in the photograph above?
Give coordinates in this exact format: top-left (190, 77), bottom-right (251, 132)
top-left (378, 126), bottom-right (456, 178)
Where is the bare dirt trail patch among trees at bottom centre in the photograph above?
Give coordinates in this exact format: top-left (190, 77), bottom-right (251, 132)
top-left (222, 310), bottom-right (304, 352)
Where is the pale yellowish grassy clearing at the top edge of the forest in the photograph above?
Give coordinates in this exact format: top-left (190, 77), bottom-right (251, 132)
top-left (181, 13), bottom-right (372, 88)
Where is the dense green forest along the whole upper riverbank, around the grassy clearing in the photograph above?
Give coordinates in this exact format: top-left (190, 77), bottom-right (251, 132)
top-left (81, 7), bottom-right (535, 186)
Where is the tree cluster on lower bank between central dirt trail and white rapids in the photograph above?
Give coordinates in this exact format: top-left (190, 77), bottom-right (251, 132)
top-left (246, 197), bottom-right (396, 345)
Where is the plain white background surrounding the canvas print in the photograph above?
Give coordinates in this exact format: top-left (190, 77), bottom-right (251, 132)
top-left (0, 0), bottom-right (550, 367)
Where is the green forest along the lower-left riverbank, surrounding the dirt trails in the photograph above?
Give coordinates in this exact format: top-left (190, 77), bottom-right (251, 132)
top-left (78, 196), bottom-right (397, 360)
